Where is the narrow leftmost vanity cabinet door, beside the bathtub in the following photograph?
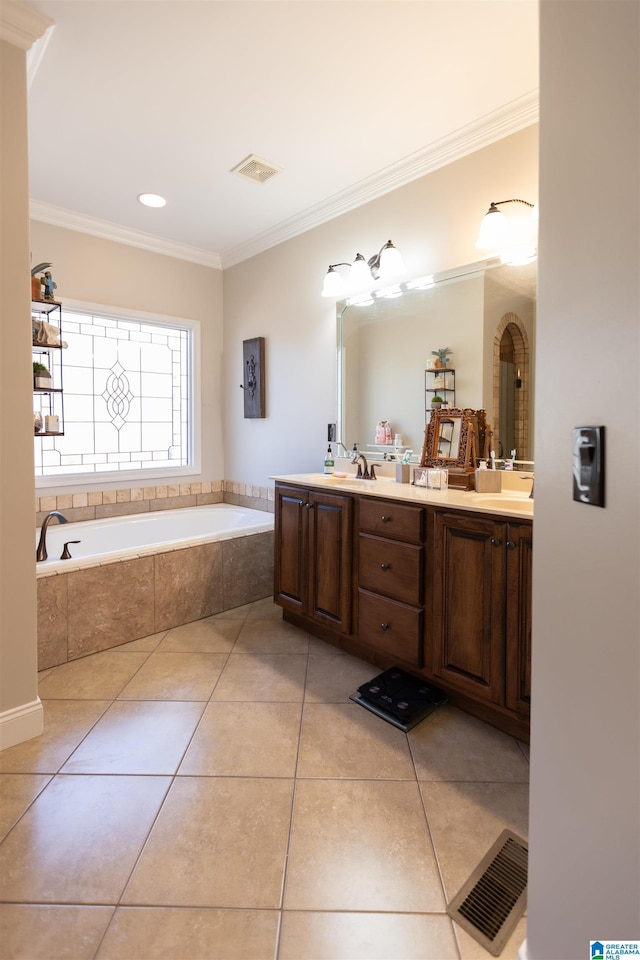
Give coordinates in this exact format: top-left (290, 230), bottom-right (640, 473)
top-left (274, 486), bottom-right (309, 613)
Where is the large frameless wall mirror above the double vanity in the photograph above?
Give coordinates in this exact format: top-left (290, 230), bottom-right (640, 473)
top-left (338, 261), bottom-right (536, 460)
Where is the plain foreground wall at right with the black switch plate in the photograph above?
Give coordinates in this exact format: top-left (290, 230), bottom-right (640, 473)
top-left (527, 0), bottom-right (640, 960)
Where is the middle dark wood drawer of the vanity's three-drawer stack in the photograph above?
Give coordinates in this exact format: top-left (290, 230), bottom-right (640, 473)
top-left (359, 533), bottom-right (424, 606)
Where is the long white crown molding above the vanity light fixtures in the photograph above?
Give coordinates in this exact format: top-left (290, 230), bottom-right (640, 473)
top-left (221, 90), bottom-right (540, 269)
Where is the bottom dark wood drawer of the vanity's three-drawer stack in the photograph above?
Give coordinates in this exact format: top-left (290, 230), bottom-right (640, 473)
top-left (359, 590), bottom-right (422, 667)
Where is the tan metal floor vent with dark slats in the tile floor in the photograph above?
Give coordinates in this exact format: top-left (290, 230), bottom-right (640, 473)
top-left (447, 830), bottom-right (529, 957)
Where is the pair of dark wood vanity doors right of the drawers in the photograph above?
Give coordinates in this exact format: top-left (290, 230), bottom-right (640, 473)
top-left (432, 512), bottom-right (532, 718)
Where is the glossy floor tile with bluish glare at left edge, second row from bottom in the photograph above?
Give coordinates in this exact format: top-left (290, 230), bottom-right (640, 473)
top-left (0, 776), bottom-right (170, 904)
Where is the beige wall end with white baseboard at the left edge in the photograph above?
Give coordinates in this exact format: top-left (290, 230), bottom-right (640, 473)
top-left (0, 40), bottom-right (42, 747)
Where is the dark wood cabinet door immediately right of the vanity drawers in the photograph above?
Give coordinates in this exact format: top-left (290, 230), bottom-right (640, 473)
top-left (433, 513), bottom-right (506, 704)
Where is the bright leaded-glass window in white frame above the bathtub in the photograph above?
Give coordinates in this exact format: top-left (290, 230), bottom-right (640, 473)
top-left (35, 307), bottom-right (194, 480)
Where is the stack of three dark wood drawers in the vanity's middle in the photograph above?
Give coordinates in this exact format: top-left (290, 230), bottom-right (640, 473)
top-left (358, 497), bottom-right (425, 667)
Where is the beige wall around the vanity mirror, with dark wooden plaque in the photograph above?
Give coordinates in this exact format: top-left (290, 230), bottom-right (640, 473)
top-left (223, 126), bottom-right (538, 485)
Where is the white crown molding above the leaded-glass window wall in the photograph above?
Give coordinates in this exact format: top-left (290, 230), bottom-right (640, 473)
top-left (29, 200), bottom-right (222, 270)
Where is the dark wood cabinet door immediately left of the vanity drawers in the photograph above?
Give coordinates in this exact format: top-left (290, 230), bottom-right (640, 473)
top-left (307, 492), bottom-right (353, 633)
